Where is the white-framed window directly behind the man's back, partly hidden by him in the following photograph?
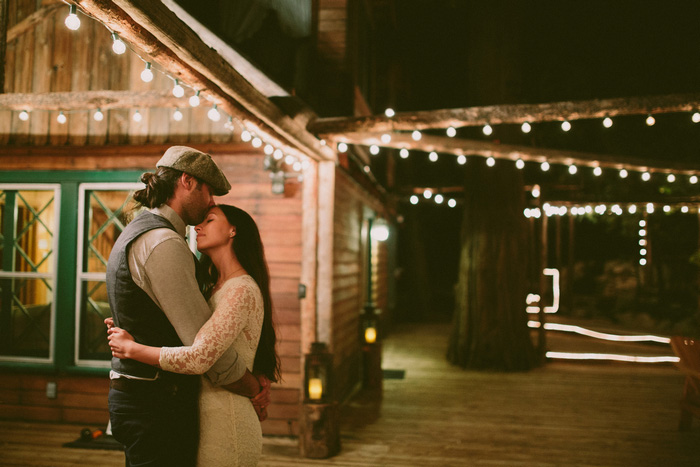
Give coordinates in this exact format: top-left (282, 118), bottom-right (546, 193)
top-left (75, 183), bottom-right (143, 367)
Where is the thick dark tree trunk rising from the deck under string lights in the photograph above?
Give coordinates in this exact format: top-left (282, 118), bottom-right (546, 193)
top-left (447, 159), bottom-right (537, 371)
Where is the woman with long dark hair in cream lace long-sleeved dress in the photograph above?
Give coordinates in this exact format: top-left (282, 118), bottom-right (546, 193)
top-left (109, 205), bottom-right (280, 467)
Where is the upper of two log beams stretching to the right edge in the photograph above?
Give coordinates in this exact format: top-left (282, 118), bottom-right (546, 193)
top-left (307, 94), bottom-right (700, 134)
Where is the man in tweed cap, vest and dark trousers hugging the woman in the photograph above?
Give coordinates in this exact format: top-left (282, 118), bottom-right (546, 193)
top-left (106, 146), bottom-right (269, 466)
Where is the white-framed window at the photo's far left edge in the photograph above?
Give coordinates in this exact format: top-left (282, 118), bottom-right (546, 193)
top-left (0, 184), bottom-right (60, 362)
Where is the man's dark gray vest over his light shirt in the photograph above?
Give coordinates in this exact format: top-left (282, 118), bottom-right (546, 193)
top-left (107, 211), bottom-right (198, 378)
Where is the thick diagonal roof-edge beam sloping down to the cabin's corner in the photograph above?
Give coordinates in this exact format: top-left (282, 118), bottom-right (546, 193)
top-left (78, 0), bottom-right (335, 160)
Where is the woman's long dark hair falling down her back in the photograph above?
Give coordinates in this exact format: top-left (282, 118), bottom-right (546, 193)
top-left (202, 204), bottom-right (280, 382)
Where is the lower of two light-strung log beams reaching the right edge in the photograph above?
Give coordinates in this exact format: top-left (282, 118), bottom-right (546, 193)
top-left (332, 133), bottom-right (700, 175)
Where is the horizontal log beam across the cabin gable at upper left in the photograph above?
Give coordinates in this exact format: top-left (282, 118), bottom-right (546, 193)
top-left (0, 91), bottom-right (189, 111)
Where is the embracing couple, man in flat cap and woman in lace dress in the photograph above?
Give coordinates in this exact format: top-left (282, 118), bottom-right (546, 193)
top-left (105, 146), bottom-right (280, 467)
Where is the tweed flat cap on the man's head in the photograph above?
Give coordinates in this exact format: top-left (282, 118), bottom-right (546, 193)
top-left (156, 146), bottom-right (231, 196)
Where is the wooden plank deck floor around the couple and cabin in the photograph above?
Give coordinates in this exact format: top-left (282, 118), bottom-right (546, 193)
top-left (0, 325), bottom-right (700, 467)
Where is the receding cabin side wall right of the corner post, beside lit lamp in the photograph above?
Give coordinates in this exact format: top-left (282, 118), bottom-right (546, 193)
top-left (332, 168), bottom-right (387, 399)
